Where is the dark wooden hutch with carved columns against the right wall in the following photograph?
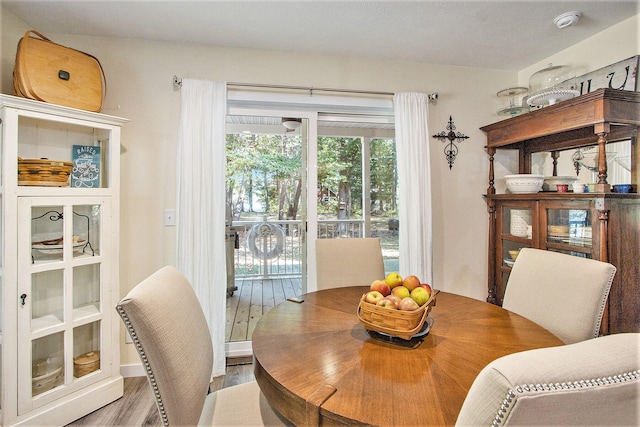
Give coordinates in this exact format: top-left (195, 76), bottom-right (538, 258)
top-left (481, 89), bottom-right (640, 334)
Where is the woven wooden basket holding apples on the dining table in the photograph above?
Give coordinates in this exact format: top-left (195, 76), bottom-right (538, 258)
top-left (358, 289), bottom-right (438, 340)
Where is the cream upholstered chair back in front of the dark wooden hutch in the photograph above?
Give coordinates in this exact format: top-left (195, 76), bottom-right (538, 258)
top-left (502, 248), bottom-right (616, 344)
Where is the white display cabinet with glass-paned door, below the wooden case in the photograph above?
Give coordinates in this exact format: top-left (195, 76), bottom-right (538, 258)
top-left (0, 95), bottom-right (126, 426)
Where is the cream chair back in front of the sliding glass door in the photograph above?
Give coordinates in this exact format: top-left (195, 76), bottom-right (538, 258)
top-left (316, 238), bottom-right (385, 290)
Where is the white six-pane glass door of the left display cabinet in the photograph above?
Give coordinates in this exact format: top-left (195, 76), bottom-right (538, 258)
top-left (18, 197), bottom-right (110, 413)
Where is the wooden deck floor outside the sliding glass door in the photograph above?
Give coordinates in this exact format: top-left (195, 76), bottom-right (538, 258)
top-left (225, 277), bottom-right (302, 342)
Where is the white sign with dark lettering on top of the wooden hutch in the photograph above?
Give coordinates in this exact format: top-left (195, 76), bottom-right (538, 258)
top-left (576, 55), bottom-right (639, 95)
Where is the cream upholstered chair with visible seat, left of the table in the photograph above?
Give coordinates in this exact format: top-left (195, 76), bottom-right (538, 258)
top-left (116, 266), bottom-right (286, 426)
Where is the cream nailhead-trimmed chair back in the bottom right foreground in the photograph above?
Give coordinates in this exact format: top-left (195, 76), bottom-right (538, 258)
top-left (456, 333), bottom-right (640, 427)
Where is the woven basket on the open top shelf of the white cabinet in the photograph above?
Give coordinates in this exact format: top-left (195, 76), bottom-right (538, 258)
top-left (18, 157), bottom-right (73, 187)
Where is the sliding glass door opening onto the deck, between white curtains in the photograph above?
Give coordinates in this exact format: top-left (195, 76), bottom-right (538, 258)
top-left (226, 97), bottom-right (397, 357)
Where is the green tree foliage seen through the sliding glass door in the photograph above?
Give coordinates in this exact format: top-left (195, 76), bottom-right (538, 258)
top-left (226, 134), bottom-right (397, 221)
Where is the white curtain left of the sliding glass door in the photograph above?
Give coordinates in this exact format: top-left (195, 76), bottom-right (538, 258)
top-left (176, 79), bottom-right (227, 377)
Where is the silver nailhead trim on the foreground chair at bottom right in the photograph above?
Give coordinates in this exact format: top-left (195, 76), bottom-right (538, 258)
top-left (491, 369), bottom-right (640, 427)
